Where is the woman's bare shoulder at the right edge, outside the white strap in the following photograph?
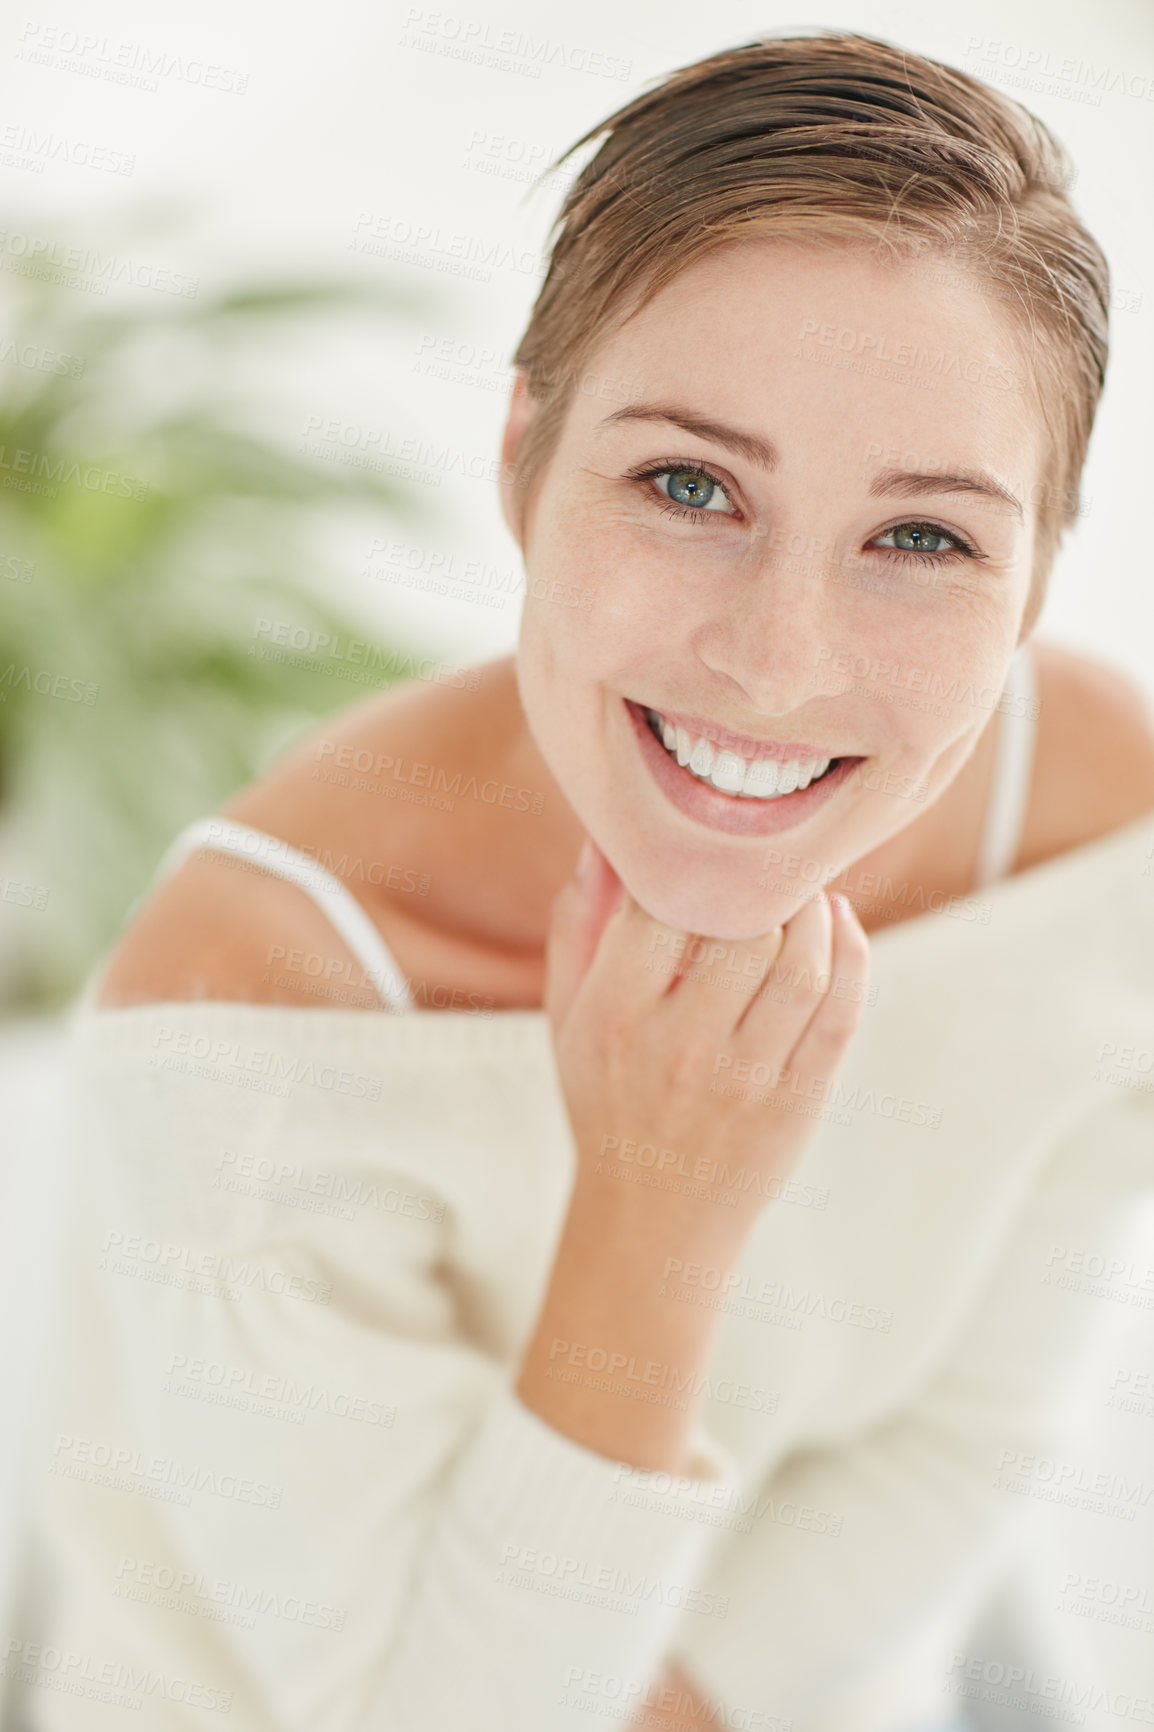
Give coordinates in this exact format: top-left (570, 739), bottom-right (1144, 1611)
top-left (1017, 641), bottom-right (1154, 871)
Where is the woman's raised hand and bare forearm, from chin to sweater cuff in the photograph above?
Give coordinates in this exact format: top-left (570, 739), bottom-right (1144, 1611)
top-left (516, 850), bottom-right (868, 1474)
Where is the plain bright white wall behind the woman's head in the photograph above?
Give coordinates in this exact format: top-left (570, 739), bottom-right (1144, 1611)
top-left (0, 0), bottom-right (1154, 691)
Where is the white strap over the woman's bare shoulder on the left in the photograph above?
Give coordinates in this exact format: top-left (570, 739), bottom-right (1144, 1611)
top-left (156, 816), bottom-right (414, 1011)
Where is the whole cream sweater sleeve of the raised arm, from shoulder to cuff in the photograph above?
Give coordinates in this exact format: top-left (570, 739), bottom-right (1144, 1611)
top-left (17, 1006), bottom-right (735, 1732)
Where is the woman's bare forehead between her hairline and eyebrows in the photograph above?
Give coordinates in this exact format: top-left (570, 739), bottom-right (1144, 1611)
top-left (577, 248), bottom-right (1043, 475)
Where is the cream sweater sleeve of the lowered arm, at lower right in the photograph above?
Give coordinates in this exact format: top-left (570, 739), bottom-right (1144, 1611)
top-left (676, 1095), bottom-right (1154, 1732)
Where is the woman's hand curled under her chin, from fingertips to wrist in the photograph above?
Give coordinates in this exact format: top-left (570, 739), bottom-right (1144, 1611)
top-left (546, 842), bottom-right (870, 1251)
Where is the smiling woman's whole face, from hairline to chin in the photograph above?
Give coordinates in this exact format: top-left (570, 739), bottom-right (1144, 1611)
top-left (506, 239), bottom-right (1041, 939)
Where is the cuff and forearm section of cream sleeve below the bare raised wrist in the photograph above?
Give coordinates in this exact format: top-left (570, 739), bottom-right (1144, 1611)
top-left (366, 1393), bottom-right (733, 1732)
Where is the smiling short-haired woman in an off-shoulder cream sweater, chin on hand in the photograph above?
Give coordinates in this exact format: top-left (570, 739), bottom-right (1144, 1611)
top-left (9, 35), bottom-right (1154, 1732)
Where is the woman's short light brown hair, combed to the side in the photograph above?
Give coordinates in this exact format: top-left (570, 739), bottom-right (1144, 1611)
top-left (513, 33), bottom-right (1111, 632)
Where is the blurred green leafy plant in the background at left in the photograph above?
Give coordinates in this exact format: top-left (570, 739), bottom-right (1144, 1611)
top-left (0, 259), bottom-right (426, 1013)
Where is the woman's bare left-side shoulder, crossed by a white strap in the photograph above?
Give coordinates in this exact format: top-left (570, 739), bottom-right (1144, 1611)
top-left (95, 661), bottom-right (502, 1010)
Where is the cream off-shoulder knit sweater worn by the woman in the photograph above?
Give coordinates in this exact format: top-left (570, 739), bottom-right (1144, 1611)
top-left (3, 816), bottom-right (1154, 1732)
